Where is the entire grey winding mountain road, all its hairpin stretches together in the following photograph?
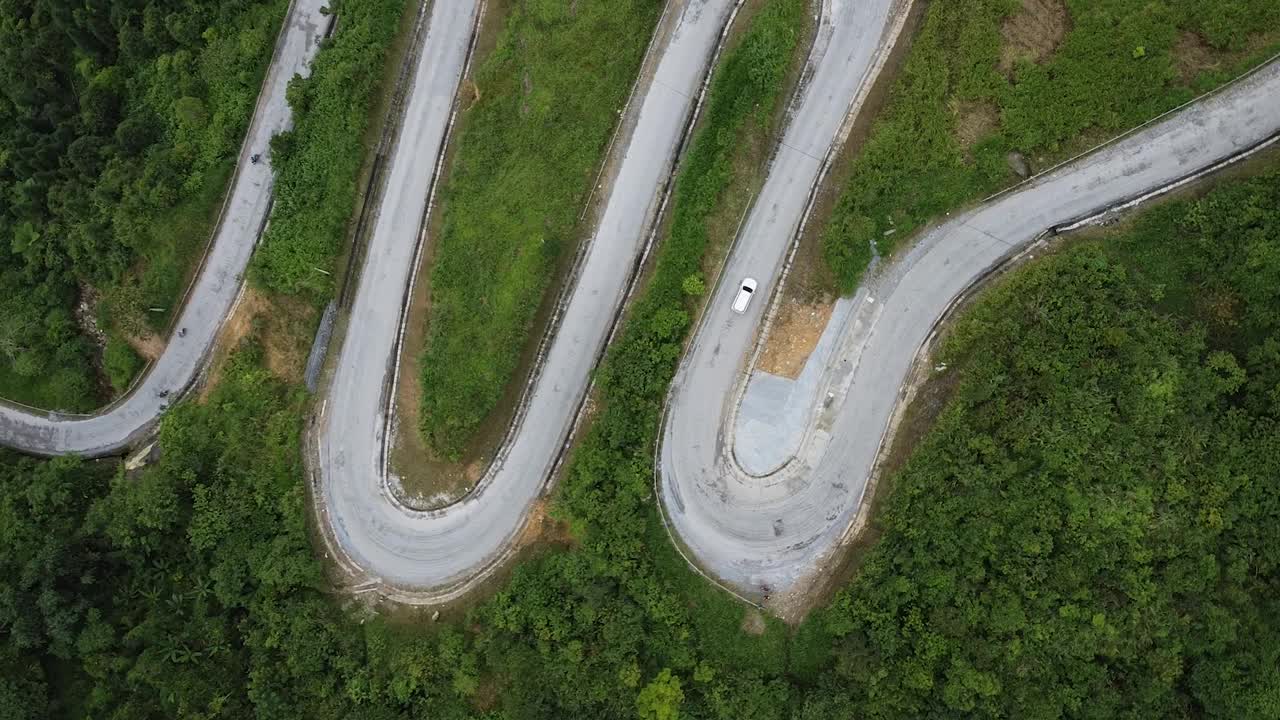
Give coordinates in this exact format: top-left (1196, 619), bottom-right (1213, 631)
top-left (0, 0), bottom-right (1280, 602)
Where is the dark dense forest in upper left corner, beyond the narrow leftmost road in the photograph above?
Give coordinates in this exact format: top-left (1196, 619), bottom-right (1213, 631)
top-left (0, 0), bottom-right (285, 409)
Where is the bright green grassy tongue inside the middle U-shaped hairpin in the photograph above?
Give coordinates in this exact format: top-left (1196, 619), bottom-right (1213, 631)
top-left (420, 0), bottom-right (662, 457)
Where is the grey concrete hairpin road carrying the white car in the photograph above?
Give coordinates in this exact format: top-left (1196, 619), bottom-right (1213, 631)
top-left (659, 56), bottom-right (1280, 597)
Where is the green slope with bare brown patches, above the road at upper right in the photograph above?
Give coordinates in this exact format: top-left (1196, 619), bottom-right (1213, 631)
top-left (822, 0), bottom-right (1280, 291)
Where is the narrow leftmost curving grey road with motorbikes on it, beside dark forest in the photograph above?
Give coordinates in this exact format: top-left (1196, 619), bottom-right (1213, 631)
top-left (0, 0), bottom-right (333, 456)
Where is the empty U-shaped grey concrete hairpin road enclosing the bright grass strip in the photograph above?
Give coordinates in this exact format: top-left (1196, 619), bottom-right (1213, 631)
top-left (314, 0), bottom-right (733, 602)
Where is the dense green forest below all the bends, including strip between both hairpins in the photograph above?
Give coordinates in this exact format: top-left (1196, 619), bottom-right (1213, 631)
top-left (0, 0), bottom-right (1280, 696)
